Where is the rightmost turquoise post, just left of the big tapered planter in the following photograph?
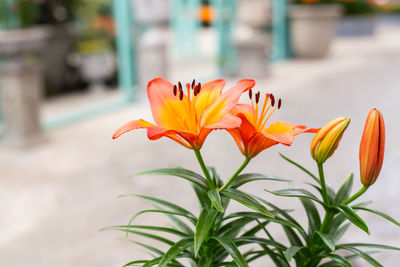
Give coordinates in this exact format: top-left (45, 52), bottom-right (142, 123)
top-left (269, 0), bottom-right (288, 61)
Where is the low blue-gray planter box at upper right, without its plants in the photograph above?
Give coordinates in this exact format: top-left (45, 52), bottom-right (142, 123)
top-left (337, 15), bottom-right (377, 37)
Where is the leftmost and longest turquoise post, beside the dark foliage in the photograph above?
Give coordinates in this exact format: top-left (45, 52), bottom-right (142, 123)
top-left (113, 0), bottom-right (137, 102)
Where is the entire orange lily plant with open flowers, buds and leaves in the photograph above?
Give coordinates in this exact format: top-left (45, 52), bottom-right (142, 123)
top-left (106, 78), bottom-right (400, 267)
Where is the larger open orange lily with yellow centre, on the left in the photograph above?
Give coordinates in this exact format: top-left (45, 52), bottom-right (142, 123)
top-left (113, 78), bottom-right (255, 150)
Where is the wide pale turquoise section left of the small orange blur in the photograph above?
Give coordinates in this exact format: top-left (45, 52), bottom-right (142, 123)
top-left (170, 0), bottom-right (201, 56)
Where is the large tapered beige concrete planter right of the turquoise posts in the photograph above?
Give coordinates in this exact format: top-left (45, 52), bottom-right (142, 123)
top-left (288, 4), bottom-right (341, 58)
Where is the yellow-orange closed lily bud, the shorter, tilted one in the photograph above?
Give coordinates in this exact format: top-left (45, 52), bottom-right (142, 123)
top-left (311, 117), bottom-right (350, 164)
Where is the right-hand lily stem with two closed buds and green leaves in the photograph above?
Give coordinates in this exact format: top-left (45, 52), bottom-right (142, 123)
top-left (268, 108), bottom-right (400, 266)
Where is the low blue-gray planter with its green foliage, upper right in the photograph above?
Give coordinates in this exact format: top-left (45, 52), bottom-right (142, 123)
top-left (338, 0), bottom-right (379, 36)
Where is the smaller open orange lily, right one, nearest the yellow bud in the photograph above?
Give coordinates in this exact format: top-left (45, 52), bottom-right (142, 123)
top-left (228, 90), bottom-right (318, 158)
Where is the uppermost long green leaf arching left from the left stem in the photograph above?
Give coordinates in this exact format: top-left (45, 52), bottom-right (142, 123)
top-left (136, 167), bottom-right (208, 190)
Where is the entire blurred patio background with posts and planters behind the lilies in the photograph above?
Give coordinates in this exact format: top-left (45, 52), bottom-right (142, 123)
top-left (0, 0), bottom-right (400, 267)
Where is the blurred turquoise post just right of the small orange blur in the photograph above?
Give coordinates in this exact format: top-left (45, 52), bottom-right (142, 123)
top-left (211, 0), bottom-right (237, 75)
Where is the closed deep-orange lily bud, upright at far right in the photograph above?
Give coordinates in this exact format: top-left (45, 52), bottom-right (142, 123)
top-left (360, 108), bottom-right (385, 187)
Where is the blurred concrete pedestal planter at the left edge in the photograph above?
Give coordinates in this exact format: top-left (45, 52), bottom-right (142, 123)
top-left (0, 28), bottom-right (48, 147)
